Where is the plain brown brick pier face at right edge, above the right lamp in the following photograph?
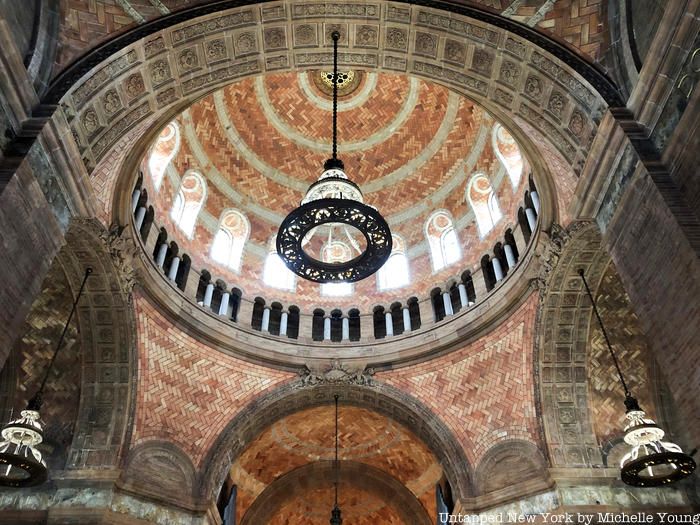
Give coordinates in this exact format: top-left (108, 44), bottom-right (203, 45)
top-left (605, 174), bottom-right (700, 446)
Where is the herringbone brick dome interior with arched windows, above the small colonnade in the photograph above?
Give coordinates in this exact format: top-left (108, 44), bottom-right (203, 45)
top-left (141, 71), bottom-right (528, 311)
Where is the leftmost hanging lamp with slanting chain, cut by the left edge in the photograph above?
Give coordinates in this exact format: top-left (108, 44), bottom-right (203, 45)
top-left (0, 268), bottom-right (92, 487)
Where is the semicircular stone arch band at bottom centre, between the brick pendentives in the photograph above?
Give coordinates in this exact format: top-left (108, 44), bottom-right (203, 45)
top-left (198, 380), bottom-right (474, 500)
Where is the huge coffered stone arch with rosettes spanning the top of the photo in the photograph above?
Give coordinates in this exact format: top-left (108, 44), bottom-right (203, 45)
top-left (43, 0), bottom-right (623, 222)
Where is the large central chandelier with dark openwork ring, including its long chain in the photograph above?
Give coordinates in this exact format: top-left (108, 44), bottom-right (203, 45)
top-left (277, 31), bottom-right (391, 283)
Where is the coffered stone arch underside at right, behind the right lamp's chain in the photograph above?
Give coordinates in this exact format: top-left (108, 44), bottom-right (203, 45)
top-left (535, 221), bottom-right (610, 468)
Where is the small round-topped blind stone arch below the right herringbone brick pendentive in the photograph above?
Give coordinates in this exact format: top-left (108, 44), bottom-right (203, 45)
top-left (474, 439), bottom-right (550, 494)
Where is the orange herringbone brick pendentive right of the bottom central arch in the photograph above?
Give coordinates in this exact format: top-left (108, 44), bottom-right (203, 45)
top-left (377, 293), bottom-right (539, 465)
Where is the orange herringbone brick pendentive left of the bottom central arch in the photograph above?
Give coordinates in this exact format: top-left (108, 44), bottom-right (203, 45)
top-left (132, 290), bottom-right (296, 466)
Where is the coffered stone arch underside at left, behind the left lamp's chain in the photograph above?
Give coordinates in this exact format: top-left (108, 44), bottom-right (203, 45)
top-left (57, 219), bottom-right (138, 469)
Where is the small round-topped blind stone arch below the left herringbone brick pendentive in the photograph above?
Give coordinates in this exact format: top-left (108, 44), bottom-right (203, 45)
top-left (117, 441), bottom-right (198, 511)
